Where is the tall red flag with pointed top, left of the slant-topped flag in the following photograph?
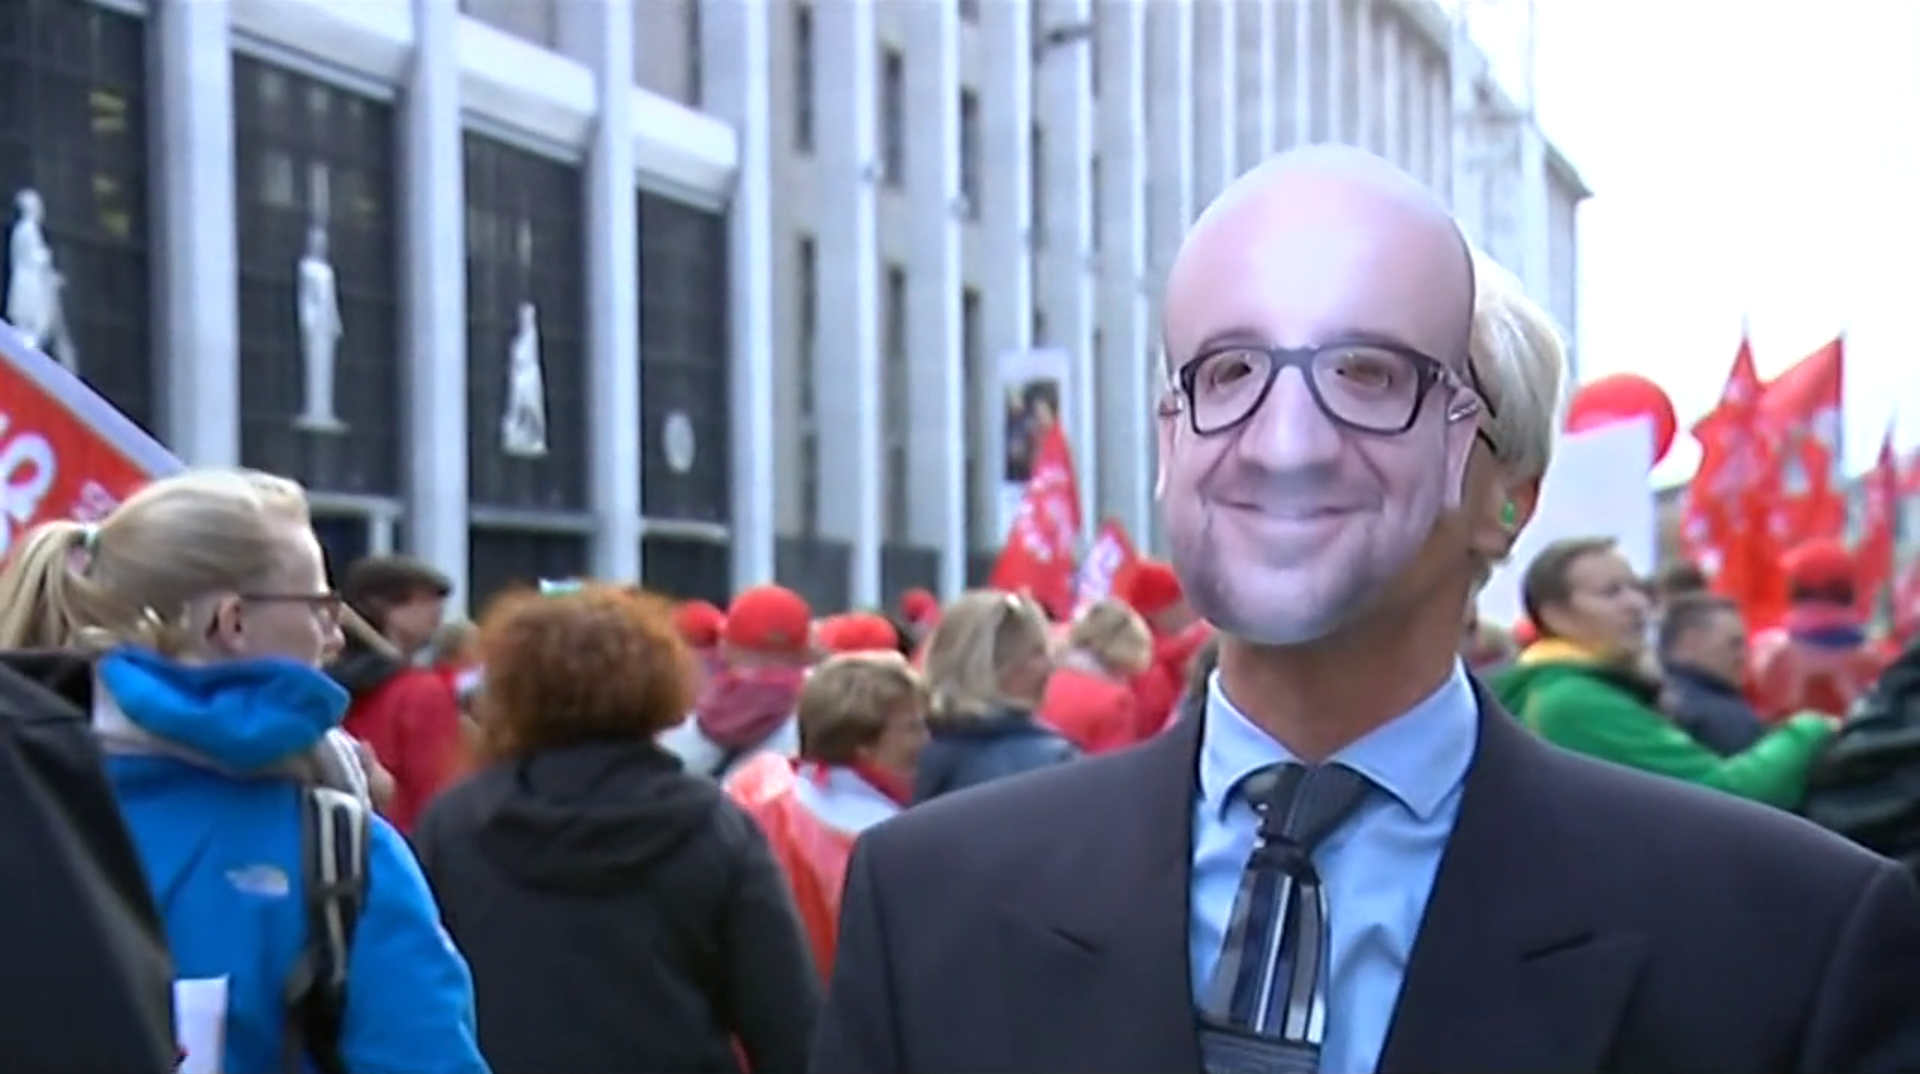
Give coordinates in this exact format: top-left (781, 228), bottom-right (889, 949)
top-left (1682, 336), bottom-right (1786, 626)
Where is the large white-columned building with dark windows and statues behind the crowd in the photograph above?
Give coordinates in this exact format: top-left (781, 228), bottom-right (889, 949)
top-left (15, 0), bottom-right (1586, 605)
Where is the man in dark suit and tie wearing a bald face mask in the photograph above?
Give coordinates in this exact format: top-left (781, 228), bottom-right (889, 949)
top-left (812, 146), bottom-right (1920, 1074)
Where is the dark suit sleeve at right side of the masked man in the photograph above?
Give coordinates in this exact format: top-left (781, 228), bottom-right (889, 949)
top-left (1793, 863), bottom-right (1920, 1074)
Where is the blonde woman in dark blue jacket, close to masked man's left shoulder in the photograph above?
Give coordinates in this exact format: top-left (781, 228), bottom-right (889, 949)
top-left (914, 590), bottom-right (1079, 801)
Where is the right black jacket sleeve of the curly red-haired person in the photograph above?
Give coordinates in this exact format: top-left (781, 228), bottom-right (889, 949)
top-left (726, 803), bottom-right (820, 1074)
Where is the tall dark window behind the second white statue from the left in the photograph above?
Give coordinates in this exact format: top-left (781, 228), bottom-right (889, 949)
top-left (234, 65), bottom-right (405, 496)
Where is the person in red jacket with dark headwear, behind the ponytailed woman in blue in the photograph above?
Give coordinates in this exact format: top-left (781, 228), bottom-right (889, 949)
top-left (326, 555), bottom-right (463, 834)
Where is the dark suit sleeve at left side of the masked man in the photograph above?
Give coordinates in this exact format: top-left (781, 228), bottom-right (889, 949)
top-left (806, 838), bottom-right (906, 1074)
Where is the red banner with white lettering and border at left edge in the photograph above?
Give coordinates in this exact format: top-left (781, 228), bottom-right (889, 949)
top-left (0, 323), bottom-right (184, 557)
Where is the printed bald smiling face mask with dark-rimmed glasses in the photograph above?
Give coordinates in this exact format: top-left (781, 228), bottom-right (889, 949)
top-left (1158, 146), bottom-right (1484, 646)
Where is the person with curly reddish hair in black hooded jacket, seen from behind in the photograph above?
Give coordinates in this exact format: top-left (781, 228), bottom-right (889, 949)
top-left (413, 586), bottom-right (822, 1074)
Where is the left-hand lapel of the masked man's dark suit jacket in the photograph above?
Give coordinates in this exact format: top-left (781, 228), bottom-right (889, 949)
top-left (998, 720), bottom-right (1200, 1074)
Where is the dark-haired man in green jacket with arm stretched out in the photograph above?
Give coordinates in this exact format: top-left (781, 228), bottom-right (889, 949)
top-left (1494, 538), bottom-right (1837, 809)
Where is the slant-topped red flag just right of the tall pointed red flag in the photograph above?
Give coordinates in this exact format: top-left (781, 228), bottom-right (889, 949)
top-left (1761, 336), bottom-right (1847, 544)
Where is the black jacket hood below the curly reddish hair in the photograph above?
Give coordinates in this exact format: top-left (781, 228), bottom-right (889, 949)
top-left (474, 742), bottom-right (720, 895)
